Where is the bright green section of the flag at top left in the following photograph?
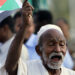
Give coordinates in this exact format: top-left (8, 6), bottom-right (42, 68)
top-left (0, 0), bottom-right (19, 10)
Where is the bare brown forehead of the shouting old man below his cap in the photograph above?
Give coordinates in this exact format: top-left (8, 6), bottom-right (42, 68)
top-left (42, 29), bottom-right (65, 40)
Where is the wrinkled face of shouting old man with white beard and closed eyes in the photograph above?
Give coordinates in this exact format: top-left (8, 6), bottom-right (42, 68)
top-left (40, 30), bottom-right (66, 69)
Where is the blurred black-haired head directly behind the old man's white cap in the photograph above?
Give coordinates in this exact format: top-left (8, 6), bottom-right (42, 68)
top-left (33, 10), bottom-right (53, 33)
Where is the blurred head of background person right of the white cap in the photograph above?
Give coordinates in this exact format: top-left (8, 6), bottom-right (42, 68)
top-left (55, 18), bottom-right (70, 42)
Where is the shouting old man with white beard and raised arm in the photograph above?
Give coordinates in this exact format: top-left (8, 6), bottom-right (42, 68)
top-left (5, 2), bottom-right (75, 75)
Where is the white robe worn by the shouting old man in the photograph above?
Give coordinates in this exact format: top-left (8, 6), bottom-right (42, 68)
top-left (0, 59), bottom-right (75, 75)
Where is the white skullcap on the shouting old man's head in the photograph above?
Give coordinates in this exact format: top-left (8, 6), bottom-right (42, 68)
top-left (37, 24), bottom-right (63, 43)
